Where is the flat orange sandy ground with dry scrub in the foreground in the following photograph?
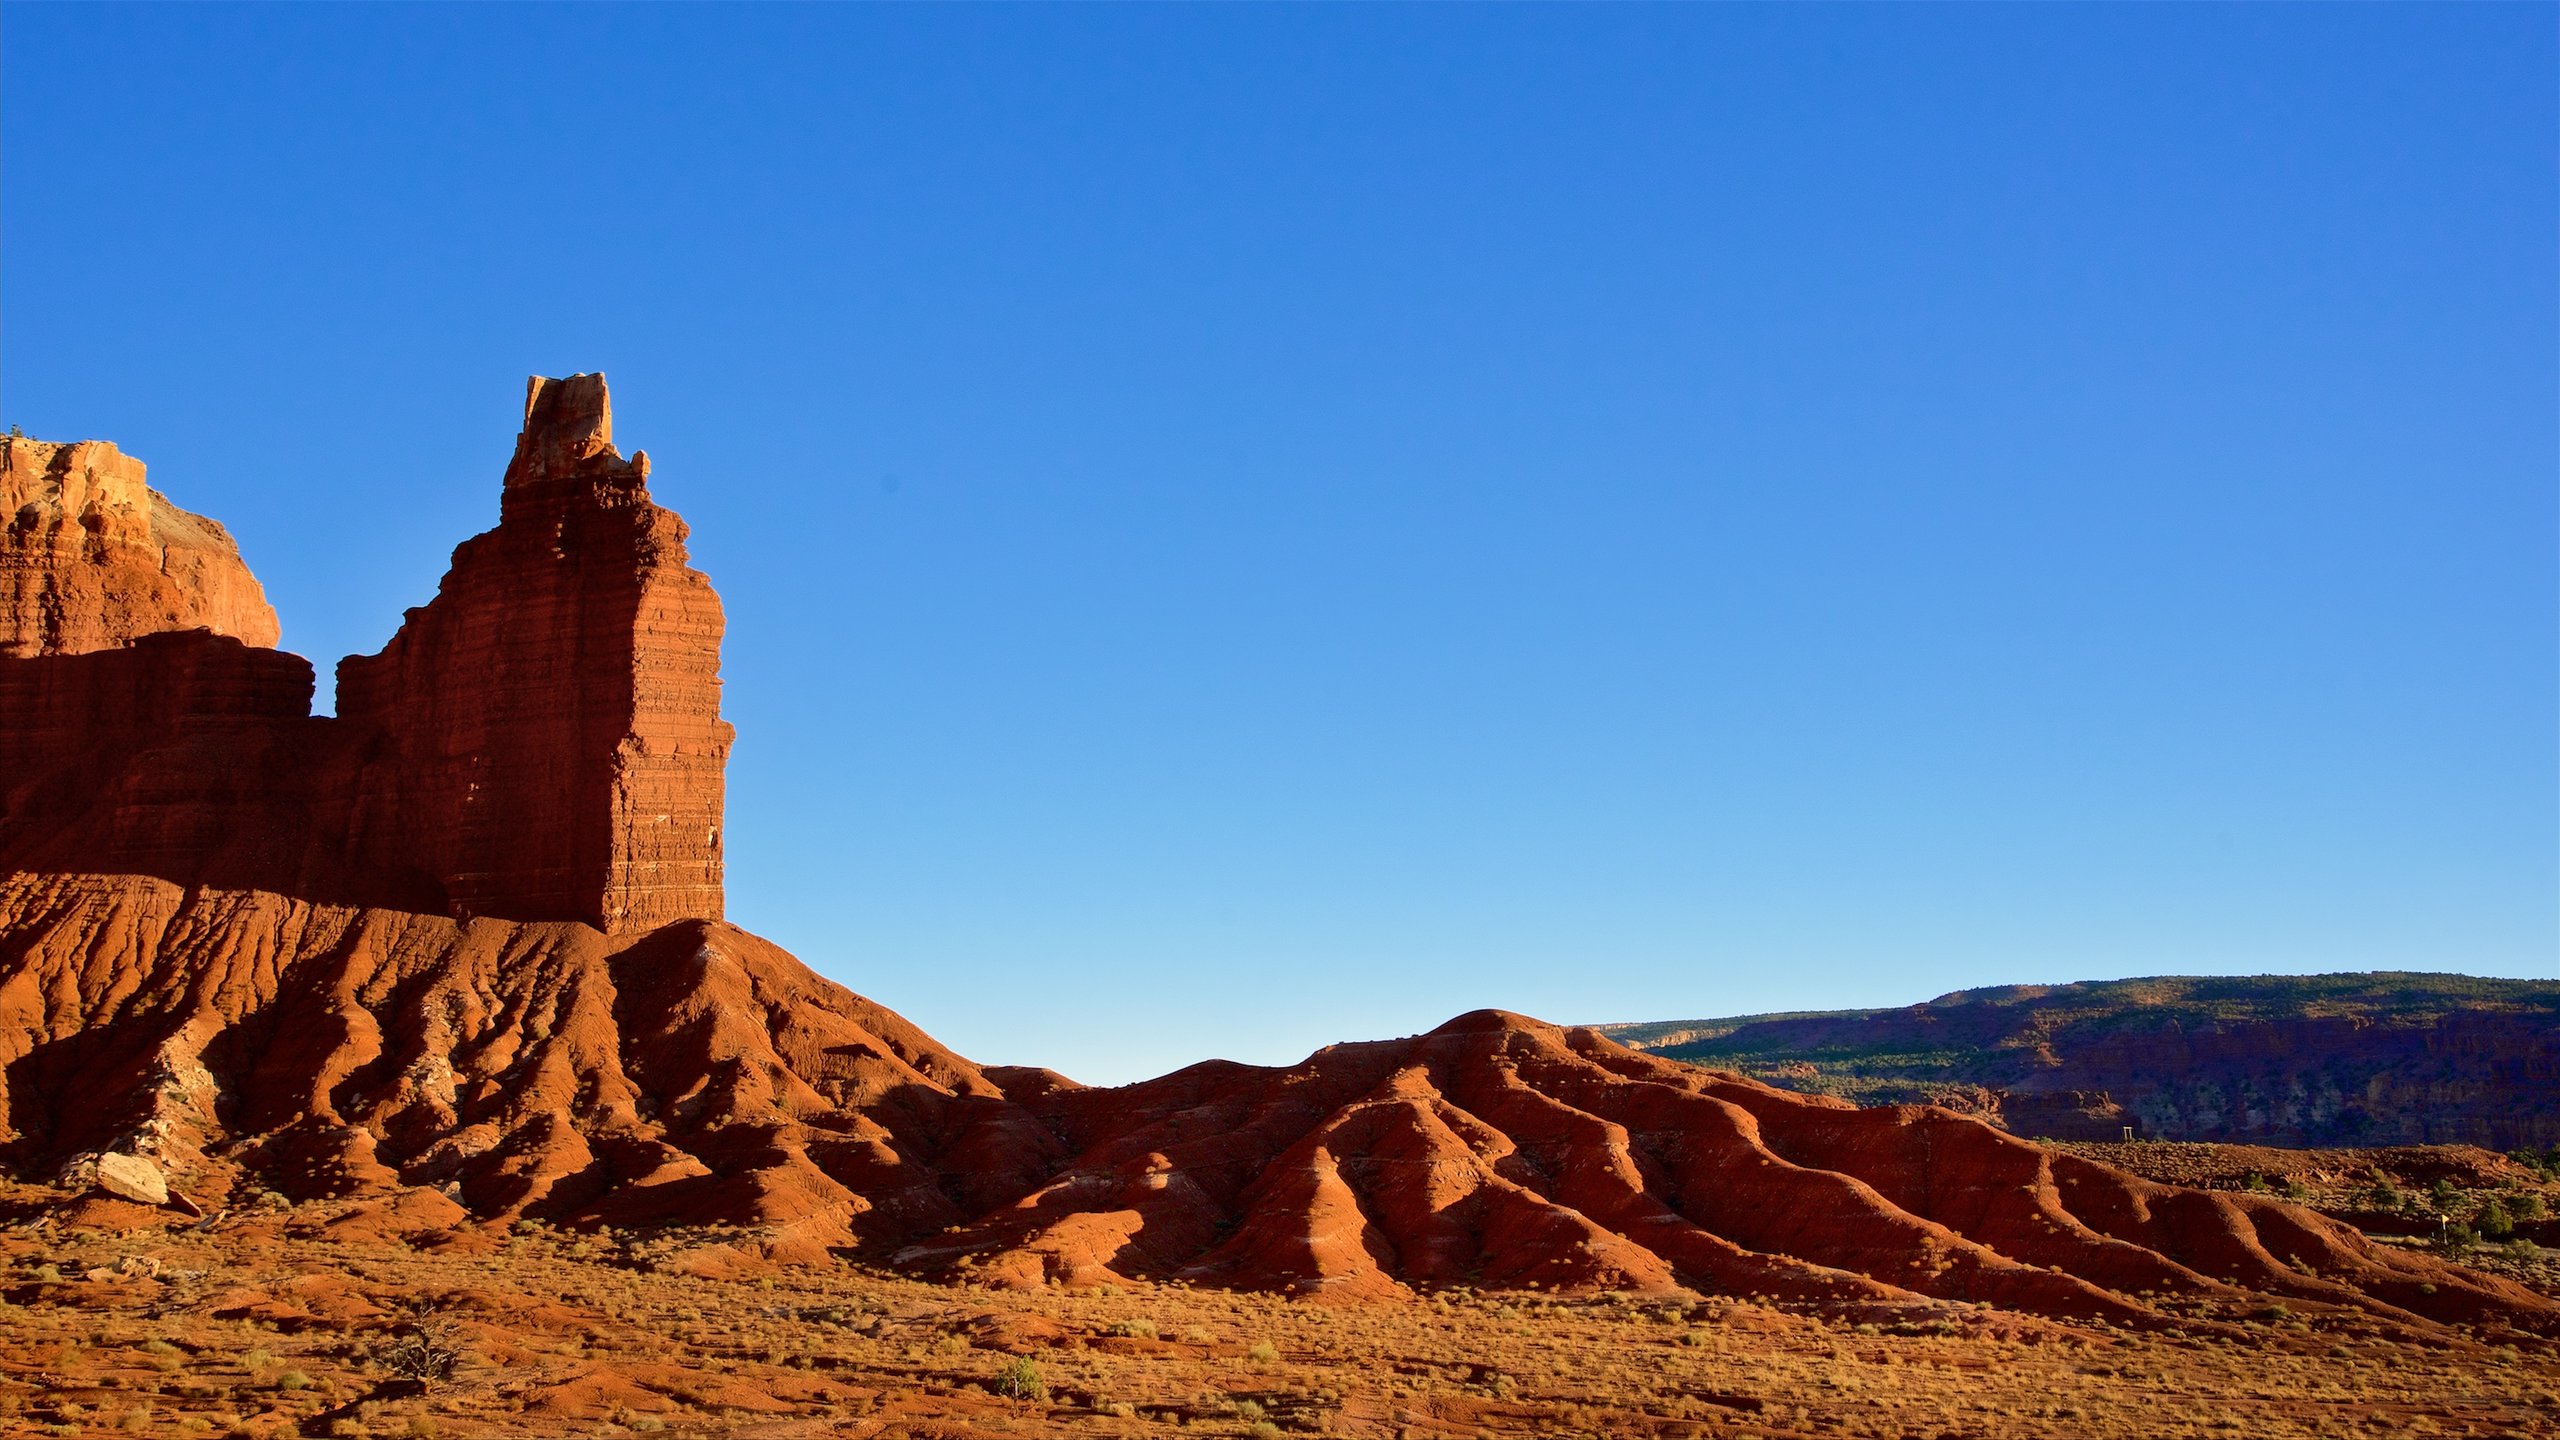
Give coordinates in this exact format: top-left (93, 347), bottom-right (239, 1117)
top-left (0, 1186), bottom-right (2560, 1440)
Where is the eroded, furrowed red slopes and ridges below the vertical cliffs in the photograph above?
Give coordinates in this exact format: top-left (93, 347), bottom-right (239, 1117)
top-left (0, 860), bottom-right (2560, 1327)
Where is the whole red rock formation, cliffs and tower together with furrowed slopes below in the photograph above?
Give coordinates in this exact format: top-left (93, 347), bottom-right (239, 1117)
top-left (0, 377), bottom-right (2560, 1335)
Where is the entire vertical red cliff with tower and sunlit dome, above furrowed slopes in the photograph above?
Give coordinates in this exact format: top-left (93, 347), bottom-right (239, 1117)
top-left (0, 374), bottom-right (730, 930)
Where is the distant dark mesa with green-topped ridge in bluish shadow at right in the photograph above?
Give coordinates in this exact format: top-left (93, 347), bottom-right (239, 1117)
top-left (1603, 971), bottom-right (2560, 1150)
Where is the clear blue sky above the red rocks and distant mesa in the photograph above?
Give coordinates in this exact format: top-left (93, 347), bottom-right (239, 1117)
top-left (0, 5), bottom-right (2560, 1079)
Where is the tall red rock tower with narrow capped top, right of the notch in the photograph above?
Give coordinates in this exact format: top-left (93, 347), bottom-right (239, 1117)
top-left (338, 374), bottom-right (730, 930)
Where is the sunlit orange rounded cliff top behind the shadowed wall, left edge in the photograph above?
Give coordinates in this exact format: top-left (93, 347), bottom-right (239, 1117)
top-left (0, 436), bottom-right (276, 659)
